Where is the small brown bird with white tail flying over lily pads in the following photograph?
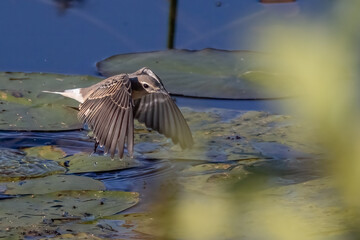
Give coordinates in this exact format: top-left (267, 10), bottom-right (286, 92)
top-left (43, 67), bottom-right (194, 159)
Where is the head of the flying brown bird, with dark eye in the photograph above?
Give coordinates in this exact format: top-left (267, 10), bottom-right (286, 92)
top-left (135, 67), bottom-right (166, 93)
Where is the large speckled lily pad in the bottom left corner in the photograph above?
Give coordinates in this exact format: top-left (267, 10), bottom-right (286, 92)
top-left (0, 191), bottom-right (139, 238)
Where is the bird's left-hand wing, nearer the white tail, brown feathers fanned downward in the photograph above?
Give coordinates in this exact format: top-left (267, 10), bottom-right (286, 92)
top-left (78, 74), bottom-right (134, 158)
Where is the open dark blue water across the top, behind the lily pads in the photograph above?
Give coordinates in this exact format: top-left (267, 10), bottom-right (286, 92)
top-left (0, 0), bottom-right (331, 75)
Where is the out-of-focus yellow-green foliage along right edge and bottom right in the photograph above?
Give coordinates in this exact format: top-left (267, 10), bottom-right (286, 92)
top-left (155, 1), bottom-right (360, 240)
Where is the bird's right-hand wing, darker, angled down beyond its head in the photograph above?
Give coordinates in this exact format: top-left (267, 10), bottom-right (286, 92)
top-left (134, 93), bottom-right (193, 148)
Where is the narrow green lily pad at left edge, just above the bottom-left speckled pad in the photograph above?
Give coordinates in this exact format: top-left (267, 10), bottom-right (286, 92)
top-left (1, 175), bottom-right (105, 195)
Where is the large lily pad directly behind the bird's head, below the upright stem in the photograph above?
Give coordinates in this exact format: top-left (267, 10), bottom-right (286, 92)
top-left (97, 49), bottom-right (291, 99)
